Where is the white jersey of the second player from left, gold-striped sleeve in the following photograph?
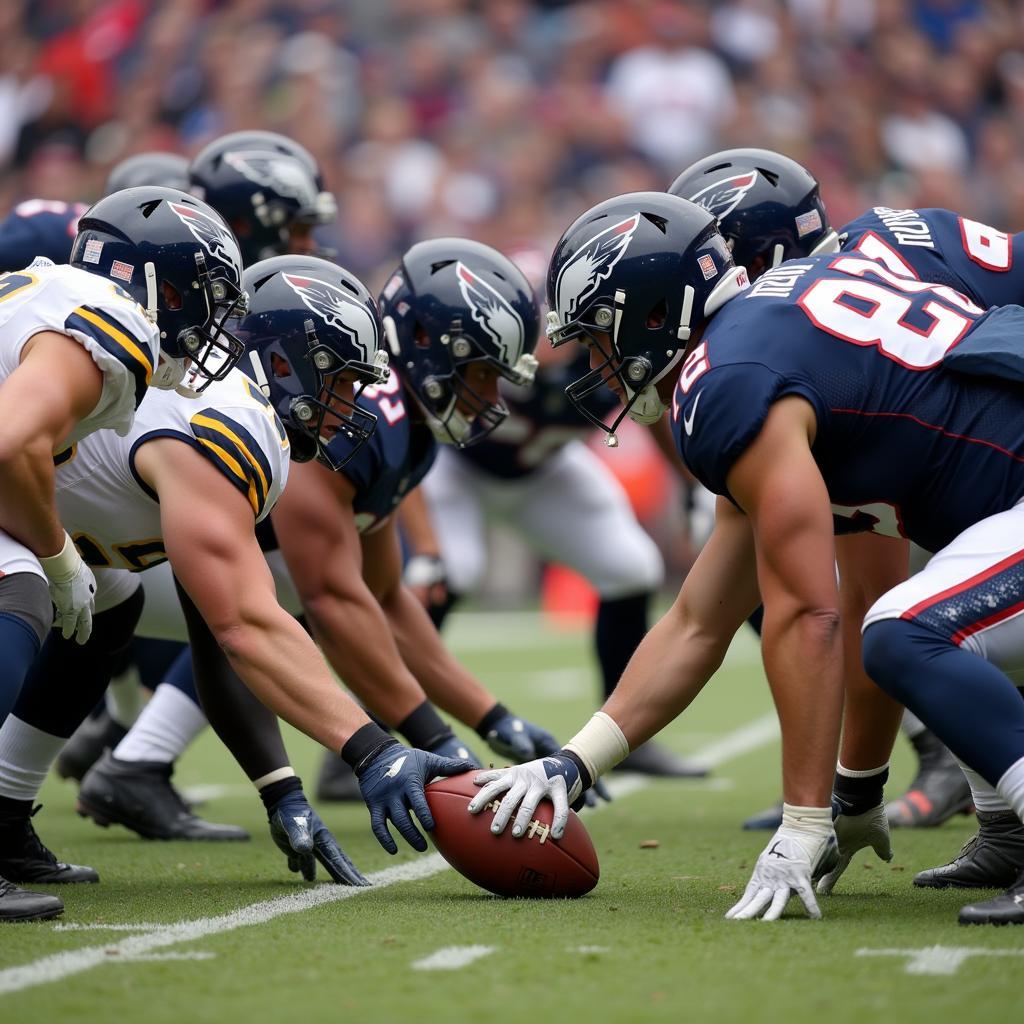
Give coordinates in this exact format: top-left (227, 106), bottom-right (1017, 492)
top-left (54, 370), bottom-right (291, 570)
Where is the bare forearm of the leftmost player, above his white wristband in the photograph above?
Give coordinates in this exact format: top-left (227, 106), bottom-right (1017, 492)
top-left (0, 438), bottom-right (65, 557)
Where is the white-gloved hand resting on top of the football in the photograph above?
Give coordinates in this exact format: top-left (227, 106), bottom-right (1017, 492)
top-left (469, 755), bottom-right (583, 839)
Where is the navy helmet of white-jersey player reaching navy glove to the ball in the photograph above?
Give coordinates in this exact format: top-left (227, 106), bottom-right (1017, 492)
top-left (236, 255), bottom-right (388, 469)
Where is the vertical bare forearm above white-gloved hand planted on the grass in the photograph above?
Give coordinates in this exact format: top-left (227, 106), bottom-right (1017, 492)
top-left (763, 606), bottom-right (843, 807)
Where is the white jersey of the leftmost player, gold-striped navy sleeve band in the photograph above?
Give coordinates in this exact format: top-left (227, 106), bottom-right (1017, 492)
top-left (0, 257), bottom-right (160, 443)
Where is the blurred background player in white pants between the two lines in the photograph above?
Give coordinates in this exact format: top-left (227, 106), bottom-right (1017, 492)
top-left (403, 250), bottom-right (707, 777)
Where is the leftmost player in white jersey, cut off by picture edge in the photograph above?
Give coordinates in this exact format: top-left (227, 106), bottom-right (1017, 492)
top-left (0, 182), bottom-right (243, 920)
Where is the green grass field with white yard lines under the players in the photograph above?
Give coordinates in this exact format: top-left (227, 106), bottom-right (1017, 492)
top-left (0, 614), bottom-right (1024, 1024)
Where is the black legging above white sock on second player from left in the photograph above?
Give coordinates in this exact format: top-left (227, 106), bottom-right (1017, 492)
top-left (14, 587), bottom-right (145, 736)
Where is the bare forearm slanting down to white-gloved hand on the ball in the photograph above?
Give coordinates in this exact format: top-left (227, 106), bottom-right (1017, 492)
top-left (602, 599), bottom-right (732, 750)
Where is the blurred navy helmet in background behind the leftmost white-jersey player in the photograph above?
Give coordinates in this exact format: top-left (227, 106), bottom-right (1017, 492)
top-left (188, 131), bottom-right (338, 265)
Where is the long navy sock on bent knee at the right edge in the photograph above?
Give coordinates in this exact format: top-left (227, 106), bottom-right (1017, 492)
top-left (863, 618), bottom-right (1024, 785)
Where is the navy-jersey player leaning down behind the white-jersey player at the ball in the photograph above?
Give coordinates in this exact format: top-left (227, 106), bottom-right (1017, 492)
top-left (72, 239), bottom-right (557, 830)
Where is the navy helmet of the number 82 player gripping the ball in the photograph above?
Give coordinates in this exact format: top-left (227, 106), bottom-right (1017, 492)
top-left (548, 193), bottom-right (750, 445)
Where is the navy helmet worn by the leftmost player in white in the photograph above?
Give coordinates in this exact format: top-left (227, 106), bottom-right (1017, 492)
top-left (69, 185), bottom-right (245, 391)
